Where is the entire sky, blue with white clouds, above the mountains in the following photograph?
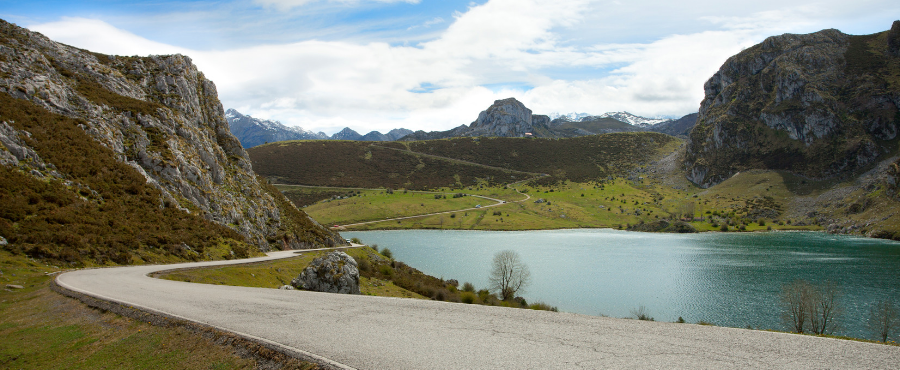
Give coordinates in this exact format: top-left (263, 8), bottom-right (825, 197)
top-left (0, 0), bottom-right (900, 134)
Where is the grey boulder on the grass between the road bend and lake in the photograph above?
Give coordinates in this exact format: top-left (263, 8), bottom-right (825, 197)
top-left (291, 252), bottom-right (360, 294)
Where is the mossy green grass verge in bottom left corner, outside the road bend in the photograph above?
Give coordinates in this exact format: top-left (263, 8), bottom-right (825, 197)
top-left (0, 251), bottom-right (316, 370)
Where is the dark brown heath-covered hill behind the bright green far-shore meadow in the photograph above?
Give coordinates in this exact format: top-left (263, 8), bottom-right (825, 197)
top-left (247, 132), bottom-right (679, 190)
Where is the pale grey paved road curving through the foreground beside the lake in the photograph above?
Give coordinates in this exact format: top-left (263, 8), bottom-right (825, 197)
top-left (57, 251), bottom-right (900, 369)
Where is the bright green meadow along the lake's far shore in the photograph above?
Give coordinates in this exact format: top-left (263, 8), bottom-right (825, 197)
top-left (304, 171), bottom-right (852, 232)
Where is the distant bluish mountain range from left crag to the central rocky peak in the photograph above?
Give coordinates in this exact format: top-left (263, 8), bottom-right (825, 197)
top-left (225, 109), bottom-right (412, 148)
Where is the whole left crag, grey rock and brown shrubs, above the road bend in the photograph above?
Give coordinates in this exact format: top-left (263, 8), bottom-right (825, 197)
top-left (0, 20), bottom-right (344, 263)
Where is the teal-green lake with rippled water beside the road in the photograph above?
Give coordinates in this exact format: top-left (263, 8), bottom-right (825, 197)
top-left (341, 229), bottom-right (900, 338)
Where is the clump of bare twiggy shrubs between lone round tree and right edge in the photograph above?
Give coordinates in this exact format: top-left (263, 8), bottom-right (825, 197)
top-left (781, 280), bottom-right (840, 335)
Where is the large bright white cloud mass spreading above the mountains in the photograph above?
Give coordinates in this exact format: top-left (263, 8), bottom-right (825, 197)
top-left (24, 0), bottom-right (890, 134)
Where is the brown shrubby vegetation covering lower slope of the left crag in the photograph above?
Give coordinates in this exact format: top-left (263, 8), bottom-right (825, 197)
top-left (0, 94), bottom-right (255, 265)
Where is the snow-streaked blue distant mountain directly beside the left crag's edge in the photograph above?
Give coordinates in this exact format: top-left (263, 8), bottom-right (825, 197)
top-left (225, 109), bottom-right (328, 148)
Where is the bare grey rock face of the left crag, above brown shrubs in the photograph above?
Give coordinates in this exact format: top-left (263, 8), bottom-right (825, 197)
top-left (0, 21), bottom-right (344, 256)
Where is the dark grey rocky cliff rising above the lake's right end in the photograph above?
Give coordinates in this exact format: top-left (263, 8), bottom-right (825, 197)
top-left (685, 21), bottom-right (900, 187)
